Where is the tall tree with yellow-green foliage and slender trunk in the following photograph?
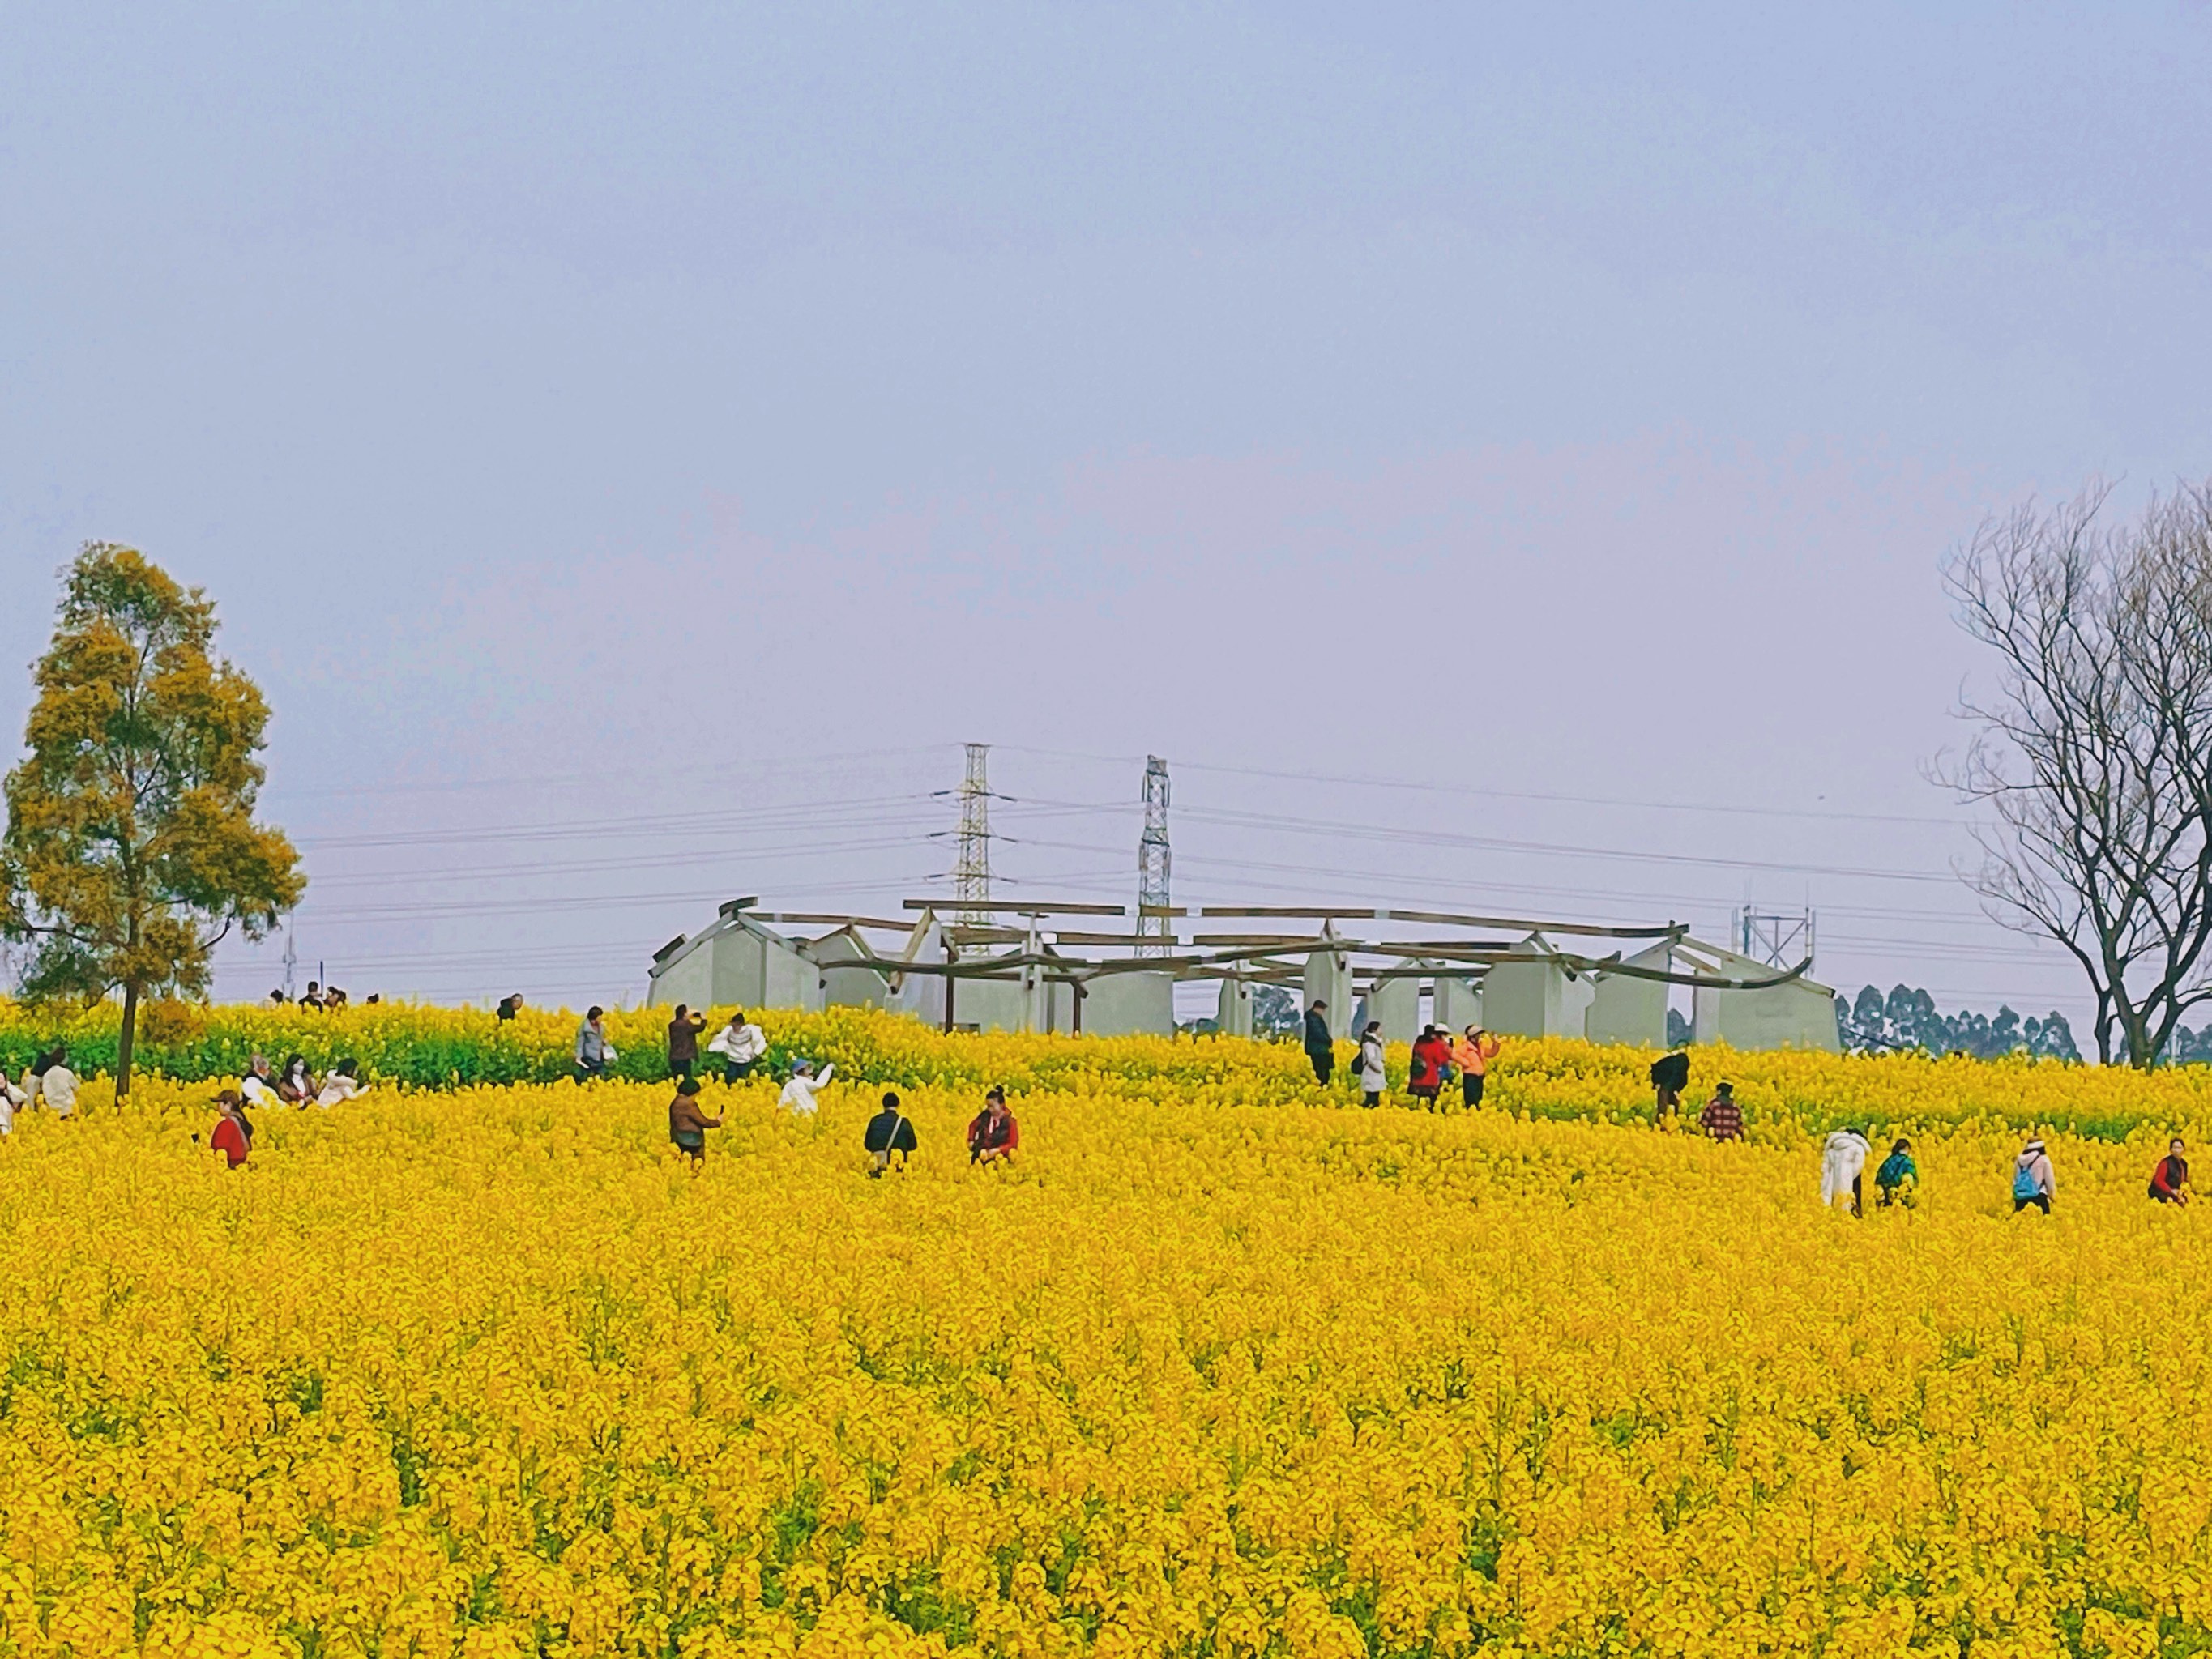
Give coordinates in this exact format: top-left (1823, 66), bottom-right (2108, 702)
top-left (0, 542), bottom-right (307, 1102)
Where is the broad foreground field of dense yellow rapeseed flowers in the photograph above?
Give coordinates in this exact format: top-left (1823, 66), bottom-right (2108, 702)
top-left (0, 1039), bottom-right (2212, 1659)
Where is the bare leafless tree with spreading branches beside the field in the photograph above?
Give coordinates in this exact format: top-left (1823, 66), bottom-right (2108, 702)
top-left (1936, 484), bottom-right (2212, 1066)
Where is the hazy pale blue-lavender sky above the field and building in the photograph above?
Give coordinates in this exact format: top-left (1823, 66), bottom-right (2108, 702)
top-left (0, 4), bottom-right (2212, 1009)
